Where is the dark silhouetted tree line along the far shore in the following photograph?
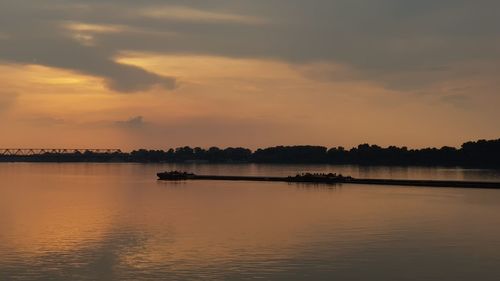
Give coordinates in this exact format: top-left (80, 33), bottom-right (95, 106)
top-left (0, 139), bottom-right (500, 167)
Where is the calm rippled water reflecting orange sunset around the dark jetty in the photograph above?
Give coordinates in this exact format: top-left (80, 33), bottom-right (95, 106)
top-left (0, 164), bottom-right (500, 281)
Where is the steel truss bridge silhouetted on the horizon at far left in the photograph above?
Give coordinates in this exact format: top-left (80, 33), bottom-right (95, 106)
top-left (0, 148), bottom-right (122, 156)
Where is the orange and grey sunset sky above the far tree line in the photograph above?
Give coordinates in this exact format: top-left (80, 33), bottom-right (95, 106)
top-left (0, 0), bottom-right (500, 150)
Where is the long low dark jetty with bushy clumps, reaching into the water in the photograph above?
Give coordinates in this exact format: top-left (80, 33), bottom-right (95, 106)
top-left (157, 171), bottom-right (500, 189)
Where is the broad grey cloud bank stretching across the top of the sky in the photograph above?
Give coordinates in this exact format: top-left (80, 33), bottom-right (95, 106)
top-left (0, 0), bottom-right (500, 92)
